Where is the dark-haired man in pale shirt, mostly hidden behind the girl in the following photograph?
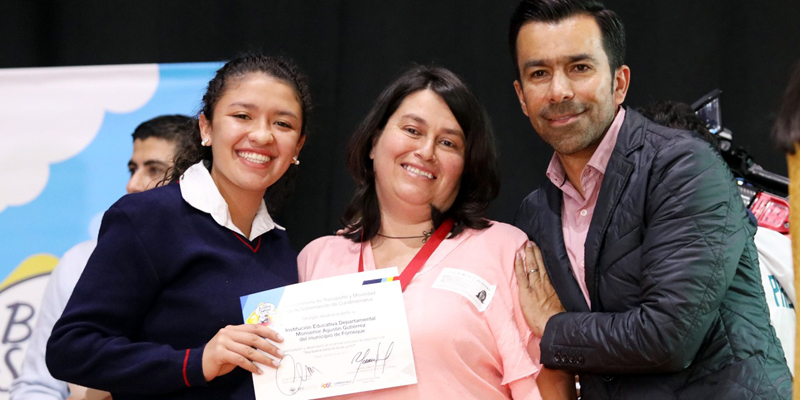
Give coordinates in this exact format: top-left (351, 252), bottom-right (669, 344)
top-left (9, 115), bottom-right (197, 400)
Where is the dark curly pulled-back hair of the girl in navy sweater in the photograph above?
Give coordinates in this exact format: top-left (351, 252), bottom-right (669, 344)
top-left (168, 53), bottom-right (311, 213)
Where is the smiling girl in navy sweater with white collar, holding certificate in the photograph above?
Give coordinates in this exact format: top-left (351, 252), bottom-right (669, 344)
top-left (46, 54), bottom-right (311, 400)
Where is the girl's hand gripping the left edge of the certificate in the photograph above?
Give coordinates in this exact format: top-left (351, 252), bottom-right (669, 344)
top-left (203, 324), bottom-right (283, 382)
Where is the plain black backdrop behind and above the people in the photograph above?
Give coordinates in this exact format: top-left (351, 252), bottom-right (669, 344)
top-left (0, 0), bottom-right (800, 249)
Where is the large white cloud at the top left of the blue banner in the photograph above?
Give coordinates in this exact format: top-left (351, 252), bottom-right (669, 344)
top-left (0, 64), bottom-right (159, 212)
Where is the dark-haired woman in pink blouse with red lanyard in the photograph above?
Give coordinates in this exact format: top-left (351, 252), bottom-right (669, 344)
top-left (298, 66), bottom-right (573, 400)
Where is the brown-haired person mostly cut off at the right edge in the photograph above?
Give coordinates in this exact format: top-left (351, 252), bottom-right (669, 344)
top-left (772, 58), bottom-right (800, 384)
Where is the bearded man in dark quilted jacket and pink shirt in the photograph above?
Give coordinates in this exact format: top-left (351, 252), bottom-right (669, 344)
top-left (509, 0), bottom-right (791, 400)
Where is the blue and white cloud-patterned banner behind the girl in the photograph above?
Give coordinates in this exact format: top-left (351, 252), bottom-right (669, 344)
top-left (0, 63), bottom-right (221, 394)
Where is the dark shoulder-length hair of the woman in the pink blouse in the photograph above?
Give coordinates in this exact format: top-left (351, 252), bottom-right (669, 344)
top-left (342, 66), bottom-right (500, 242)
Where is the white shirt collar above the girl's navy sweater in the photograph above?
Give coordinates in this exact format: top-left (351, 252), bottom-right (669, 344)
top-left (180, 161), bottom-right (285, 241)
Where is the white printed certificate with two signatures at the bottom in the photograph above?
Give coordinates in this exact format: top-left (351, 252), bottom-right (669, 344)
top-left (241, 268), bottom-right (417, 400)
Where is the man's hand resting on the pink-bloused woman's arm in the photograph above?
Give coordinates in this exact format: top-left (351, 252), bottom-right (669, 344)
top-left (514, 242), bottom-right (566, 337)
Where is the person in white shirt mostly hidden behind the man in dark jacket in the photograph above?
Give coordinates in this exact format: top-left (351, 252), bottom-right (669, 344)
top-left (639, 101), bottom-right (797, 375)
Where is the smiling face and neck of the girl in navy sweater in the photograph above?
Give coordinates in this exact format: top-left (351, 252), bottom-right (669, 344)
top-left (200, 72), bottom-right (305, 236)
